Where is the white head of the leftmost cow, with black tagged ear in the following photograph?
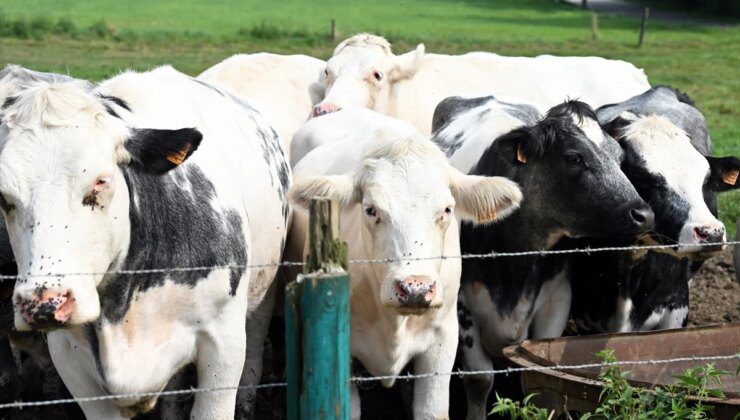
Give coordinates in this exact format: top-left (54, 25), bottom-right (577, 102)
top-left (0, 76), bottom-right (201, 330)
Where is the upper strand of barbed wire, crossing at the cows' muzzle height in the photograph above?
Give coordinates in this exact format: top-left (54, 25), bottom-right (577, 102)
top-left (0, 241), bottom-right (740, 281)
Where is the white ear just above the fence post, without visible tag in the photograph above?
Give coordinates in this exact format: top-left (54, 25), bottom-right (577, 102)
top-left (288, 175), bottom-right (359, 208)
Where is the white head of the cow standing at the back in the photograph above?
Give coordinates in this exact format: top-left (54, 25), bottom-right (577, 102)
top-left (313, 34), bottom-right (424, 117)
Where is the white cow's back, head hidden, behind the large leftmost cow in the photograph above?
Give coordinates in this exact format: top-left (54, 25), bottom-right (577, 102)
top-left (197, 53), bottom-right (326, 158)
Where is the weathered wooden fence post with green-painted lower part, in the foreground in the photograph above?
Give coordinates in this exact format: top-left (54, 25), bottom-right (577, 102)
top-left (285, 200), bottom-right (350, 420)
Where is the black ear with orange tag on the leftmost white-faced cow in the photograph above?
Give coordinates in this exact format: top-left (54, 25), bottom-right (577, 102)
top-left (124, 128), bottom-right (203, 175)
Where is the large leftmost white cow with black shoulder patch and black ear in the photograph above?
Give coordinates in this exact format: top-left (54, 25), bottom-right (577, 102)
top-left (0, 66), bottom-right (290, 419)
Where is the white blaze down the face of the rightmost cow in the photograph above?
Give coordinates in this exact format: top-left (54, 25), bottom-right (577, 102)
top-left (623, 115), bottom-right (724, 253)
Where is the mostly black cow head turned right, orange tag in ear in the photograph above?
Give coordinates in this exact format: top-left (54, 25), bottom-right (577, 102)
top-left (482, 101), bottom-right (654, 246)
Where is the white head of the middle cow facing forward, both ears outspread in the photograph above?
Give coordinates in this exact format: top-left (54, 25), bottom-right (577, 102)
top-left (291, 138), bottom-right (521, 313)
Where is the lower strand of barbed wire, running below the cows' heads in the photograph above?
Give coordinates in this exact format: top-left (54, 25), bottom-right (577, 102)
top-left (0, 353), bottom-right (740, 410)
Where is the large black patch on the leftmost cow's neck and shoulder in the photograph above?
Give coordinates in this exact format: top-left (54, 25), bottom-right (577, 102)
top-left (101, 164), bottom-right (247, 322)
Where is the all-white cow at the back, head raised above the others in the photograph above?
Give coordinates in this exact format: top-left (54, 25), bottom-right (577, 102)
top-left (313, 34), bottom-right (650, 133)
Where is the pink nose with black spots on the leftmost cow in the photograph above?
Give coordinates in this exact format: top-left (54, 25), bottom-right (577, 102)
top-left (15, 290), bottom-right (75, 328)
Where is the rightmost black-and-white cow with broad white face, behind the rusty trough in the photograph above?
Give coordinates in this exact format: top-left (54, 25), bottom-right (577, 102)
top-left (572, 86), bottom-right (740, 334)
